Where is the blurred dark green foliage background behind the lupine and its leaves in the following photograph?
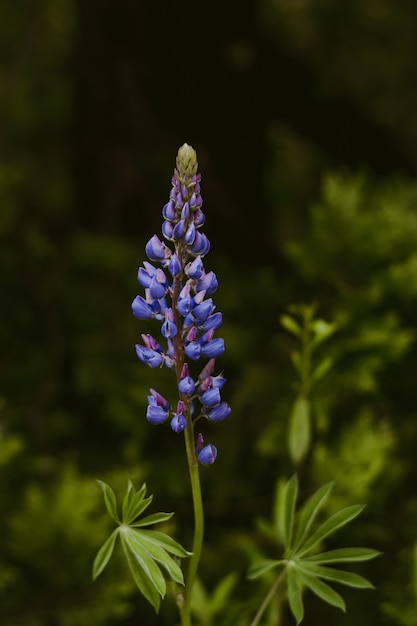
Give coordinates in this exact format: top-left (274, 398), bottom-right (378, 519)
top-left (0, 0), bottom-right (417, 626)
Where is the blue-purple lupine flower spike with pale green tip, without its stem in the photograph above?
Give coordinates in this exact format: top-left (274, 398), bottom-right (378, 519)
top-left (132, 144), bottom-right (231, 465)
